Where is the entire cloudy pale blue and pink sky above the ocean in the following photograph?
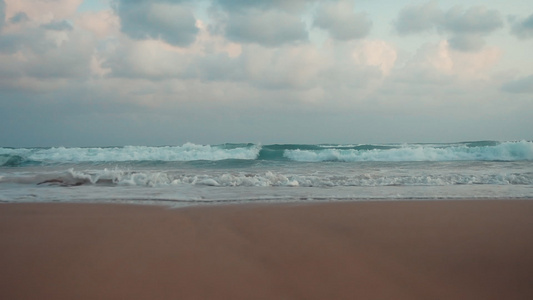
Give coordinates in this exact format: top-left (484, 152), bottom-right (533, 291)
top-left (0, 0), bottom-right (533, 147)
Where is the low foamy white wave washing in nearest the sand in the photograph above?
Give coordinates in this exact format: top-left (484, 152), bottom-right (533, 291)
top-left (5, 168), bottom-right (533, 188)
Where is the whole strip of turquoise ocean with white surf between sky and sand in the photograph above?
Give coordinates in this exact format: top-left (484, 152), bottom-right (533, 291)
top-left (0, 141), bottom-right (533, 207)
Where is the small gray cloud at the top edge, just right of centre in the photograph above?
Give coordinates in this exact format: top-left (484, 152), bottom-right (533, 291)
top-left (314, 3), bottom-right (372, 40)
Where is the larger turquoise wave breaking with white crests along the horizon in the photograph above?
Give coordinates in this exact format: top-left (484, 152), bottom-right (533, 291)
top-left (0, 141), bottom-right (533, 167)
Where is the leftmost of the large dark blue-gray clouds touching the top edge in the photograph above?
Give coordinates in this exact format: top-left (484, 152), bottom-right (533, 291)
top-left (115, 0), bottom-right (198, 46)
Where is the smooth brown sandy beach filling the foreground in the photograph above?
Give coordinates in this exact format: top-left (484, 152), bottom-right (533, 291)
top-left (0, 200), bottom-right (533, 300)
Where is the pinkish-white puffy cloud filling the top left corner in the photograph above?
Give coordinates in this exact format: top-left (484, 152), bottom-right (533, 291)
top-left (0, 0), bottom-right (104, 92)
